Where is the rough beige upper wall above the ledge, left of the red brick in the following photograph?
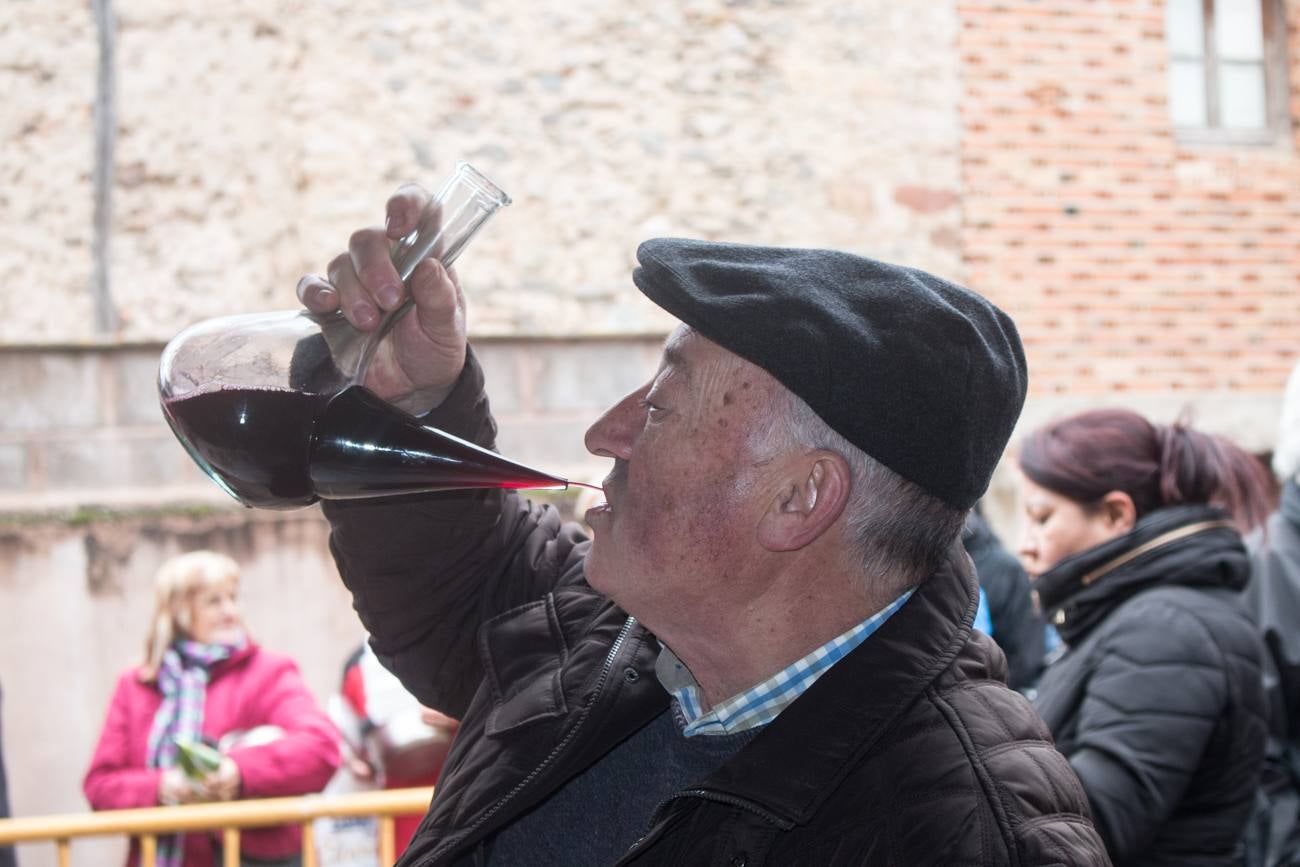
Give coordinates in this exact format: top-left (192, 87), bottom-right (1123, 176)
top-left (0, 0), bottom-right (959, 343)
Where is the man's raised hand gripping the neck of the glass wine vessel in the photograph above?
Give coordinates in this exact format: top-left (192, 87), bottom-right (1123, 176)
top-left (298, 185), bottom-right (465, 415)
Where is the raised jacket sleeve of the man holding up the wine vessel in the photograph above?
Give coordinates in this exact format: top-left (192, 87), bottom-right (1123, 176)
top-left (322, 352), bottom-right (588, 719)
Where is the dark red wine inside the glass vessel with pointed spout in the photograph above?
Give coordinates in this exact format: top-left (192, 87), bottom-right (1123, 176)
top-left (163, 386), bottom-right (569, 510)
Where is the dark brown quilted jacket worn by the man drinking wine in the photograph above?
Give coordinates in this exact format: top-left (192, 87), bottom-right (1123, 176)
top-left (325, 353), bottom-right (1108, 867)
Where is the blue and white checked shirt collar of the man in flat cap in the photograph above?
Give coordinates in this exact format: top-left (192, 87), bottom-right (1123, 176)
top-left (655, 590), bottom-right (911, 737)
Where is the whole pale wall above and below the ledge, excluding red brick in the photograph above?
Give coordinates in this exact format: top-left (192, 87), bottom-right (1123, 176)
top-left (0, 0), bottom-right (961, 847)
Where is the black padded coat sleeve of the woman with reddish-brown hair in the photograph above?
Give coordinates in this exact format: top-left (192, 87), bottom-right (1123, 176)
top-left (1067, 599), bottom-right (1230, 863)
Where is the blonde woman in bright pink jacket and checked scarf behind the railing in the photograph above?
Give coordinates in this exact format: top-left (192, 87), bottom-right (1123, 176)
top-left (83, 551), bottom-right (339, 867)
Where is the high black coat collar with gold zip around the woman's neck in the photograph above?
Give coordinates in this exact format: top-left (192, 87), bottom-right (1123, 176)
top-left (1034, 506), bottom-right (1251, 643)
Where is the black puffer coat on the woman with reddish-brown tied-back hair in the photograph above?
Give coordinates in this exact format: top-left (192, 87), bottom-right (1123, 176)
top-left (1034, 506), bottom-right (1265, 867)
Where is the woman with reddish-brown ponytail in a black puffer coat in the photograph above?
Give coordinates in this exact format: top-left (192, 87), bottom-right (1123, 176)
top-left (1019, 409), bottom-right (1269, 867)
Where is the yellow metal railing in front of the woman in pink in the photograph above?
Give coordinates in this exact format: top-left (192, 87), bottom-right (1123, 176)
top-left (0, 788), bottom-right (433, 867)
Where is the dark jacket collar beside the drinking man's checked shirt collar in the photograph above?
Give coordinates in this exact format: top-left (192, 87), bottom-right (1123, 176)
top-left (705, 541), bottom-right (979, 824)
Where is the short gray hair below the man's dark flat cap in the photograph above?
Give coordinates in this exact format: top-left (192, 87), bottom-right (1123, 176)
top-left (767, 389), bottom-right (966, 595)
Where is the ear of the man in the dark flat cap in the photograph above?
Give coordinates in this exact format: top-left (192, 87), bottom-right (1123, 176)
top-left (758, 450), bottom-right (853, 551)
